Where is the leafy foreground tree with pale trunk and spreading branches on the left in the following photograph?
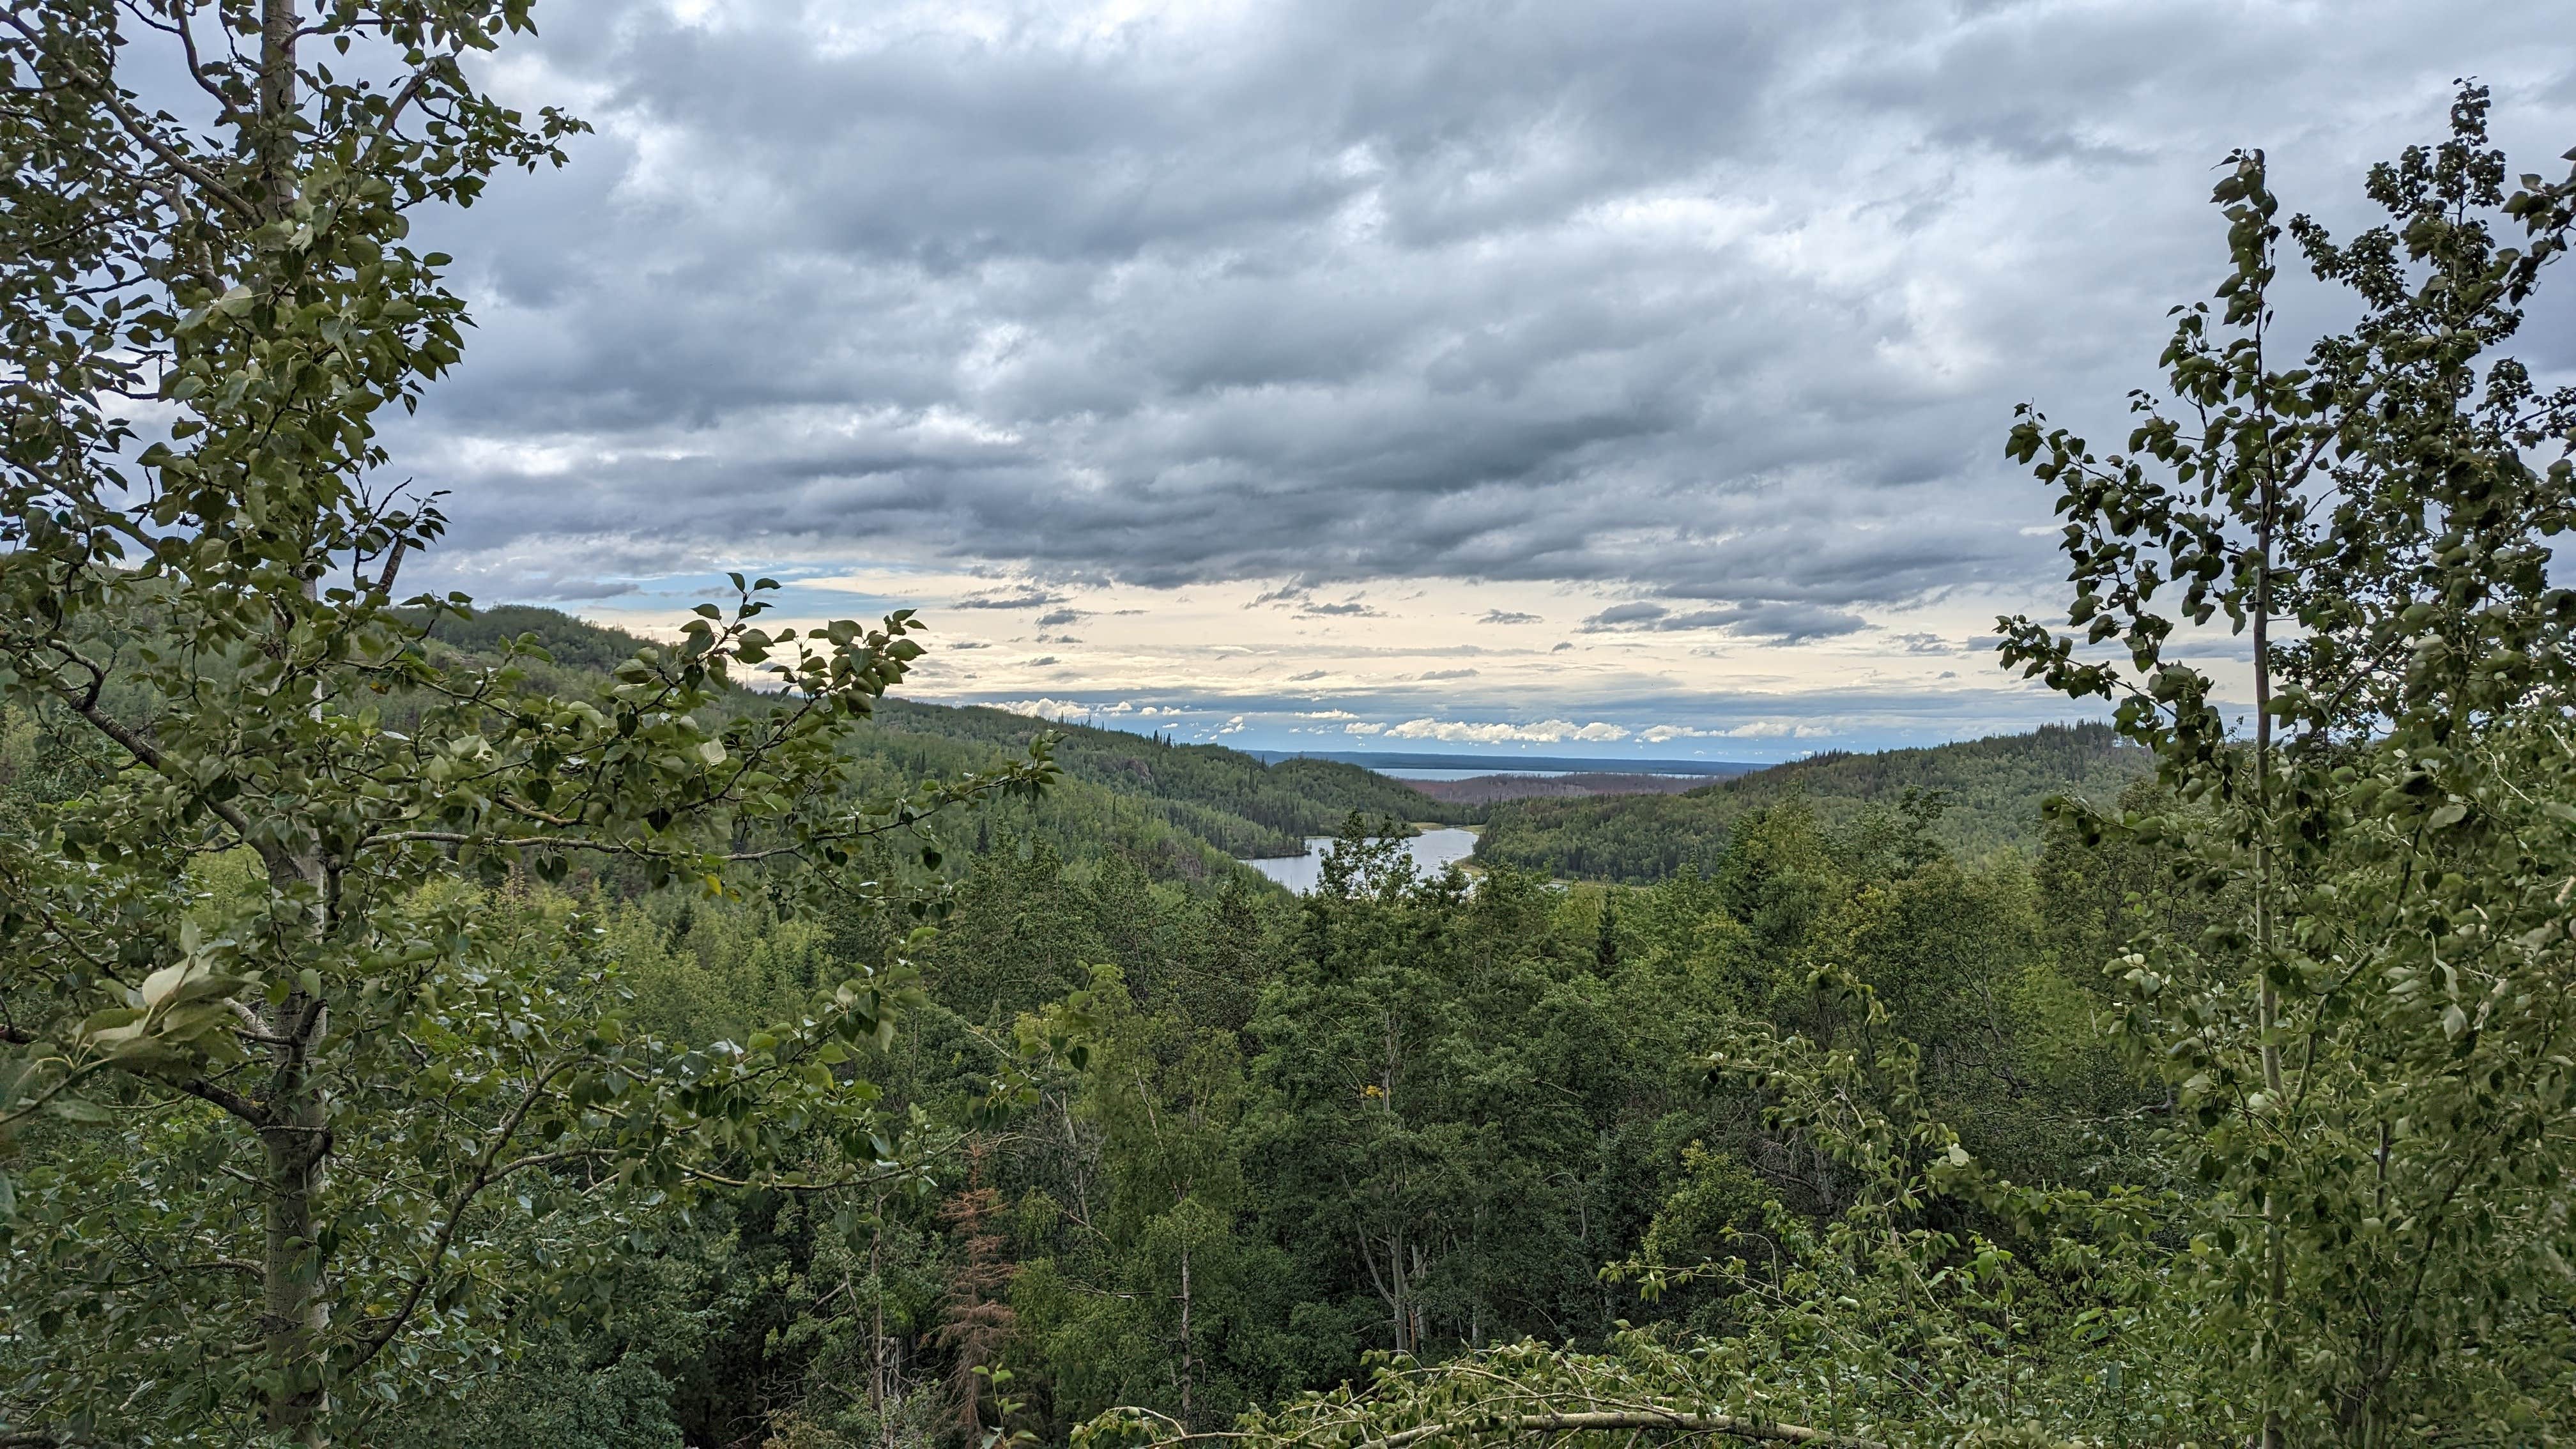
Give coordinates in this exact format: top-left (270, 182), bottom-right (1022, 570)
top-left (0, 0), bottom-right (1048, 1444)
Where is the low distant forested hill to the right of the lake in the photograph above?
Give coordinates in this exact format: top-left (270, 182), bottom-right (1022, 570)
top-left (1476, 724), bottom-right (2149, 882)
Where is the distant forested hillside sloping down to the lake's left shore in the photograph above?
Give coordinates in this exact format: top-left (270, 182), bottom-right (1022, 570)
top-left (417, 603), bottom-right (1478, 861)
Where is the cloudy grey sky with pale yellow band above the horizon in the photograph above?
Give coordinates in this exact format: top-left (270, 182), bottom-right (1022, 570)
top-left (387, 0), bottom-right (2576, 760)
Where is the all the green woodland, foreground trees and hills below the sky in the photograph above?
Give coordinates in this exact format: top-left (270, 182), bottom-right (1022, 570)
top-left (0, 0), bottom-right (2576, 1449)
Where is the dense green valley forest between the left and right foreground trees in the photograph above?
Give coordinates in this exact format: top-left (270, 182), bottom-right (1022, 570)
top-left (0, 686), bottom-right (2195, 1444)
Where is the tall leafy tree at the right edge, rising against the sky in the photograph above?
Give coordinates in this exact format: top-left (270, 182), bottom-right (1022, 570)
top-left (2004, 88), bottom-right (2576, 1444)
